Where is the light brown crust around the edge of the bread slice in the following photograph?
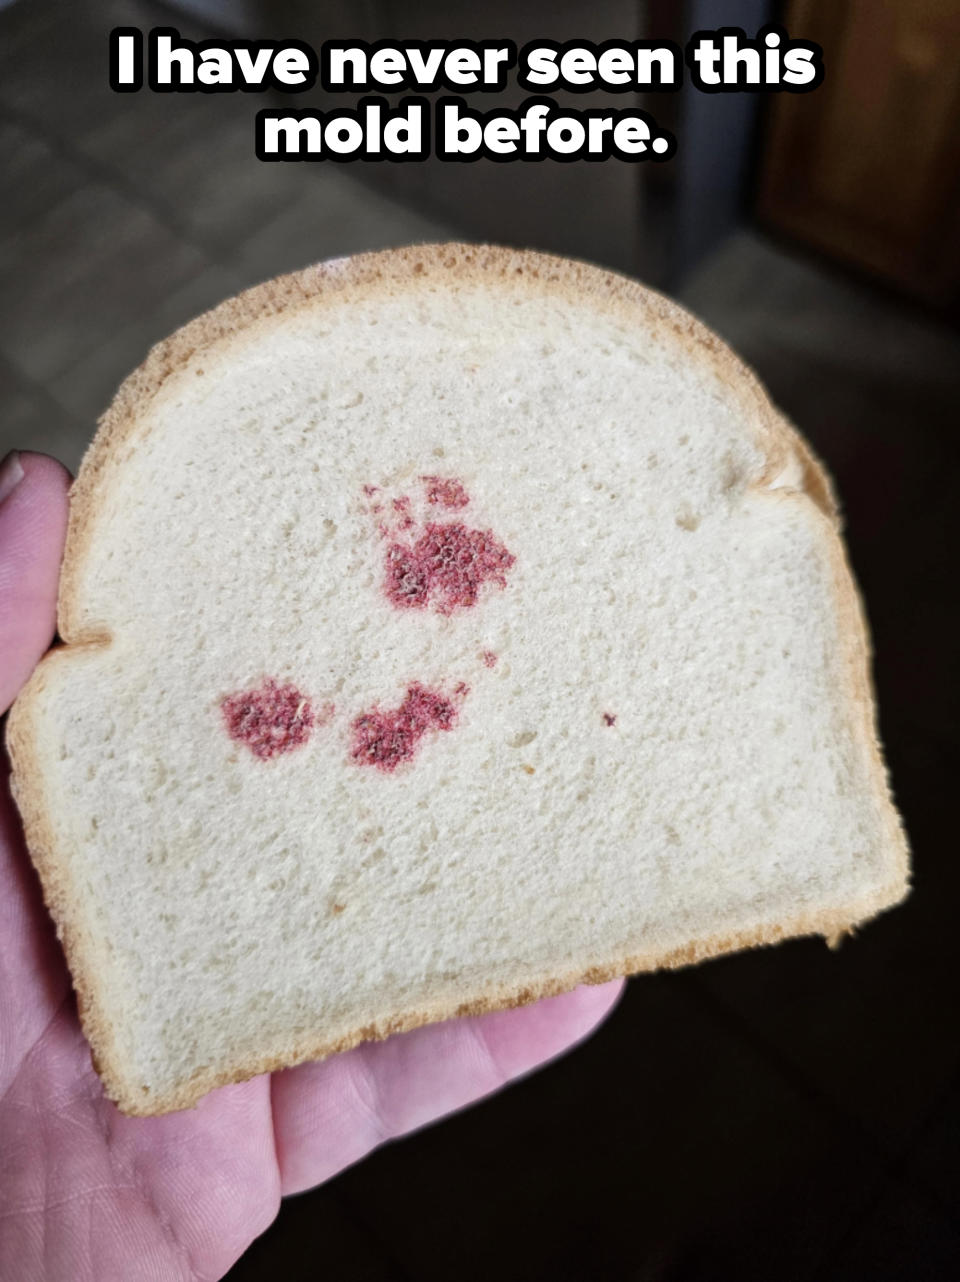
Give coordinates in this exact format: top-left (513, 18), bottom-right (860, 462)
top-left (6, 244), bottom-right (909, 1115)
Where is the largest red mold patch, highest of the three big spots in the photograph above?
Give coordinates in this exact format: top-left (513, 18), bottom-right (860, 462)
top-left (386, 520), bottom-right (515, 614)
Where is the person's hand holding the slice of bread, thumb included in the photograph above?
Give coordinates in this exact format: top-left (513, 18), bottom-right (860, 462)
top-left (0, 455), bottom-right (619, 1282)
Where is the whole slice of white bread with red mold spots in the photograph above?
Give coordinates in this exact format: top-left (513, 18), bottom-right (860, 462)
top-left (8, 245), bottom-right (907, 1113)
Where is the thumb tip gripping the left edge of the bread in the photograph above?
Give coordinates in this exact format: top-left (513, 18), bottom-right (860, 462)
top-left (0, 453), bottom-right (70, 713)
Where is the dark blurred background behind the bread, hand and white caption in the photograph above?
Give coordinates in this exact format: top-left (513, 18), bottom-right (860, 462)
top-left (0, 0), bottom-right (960, 1282)
